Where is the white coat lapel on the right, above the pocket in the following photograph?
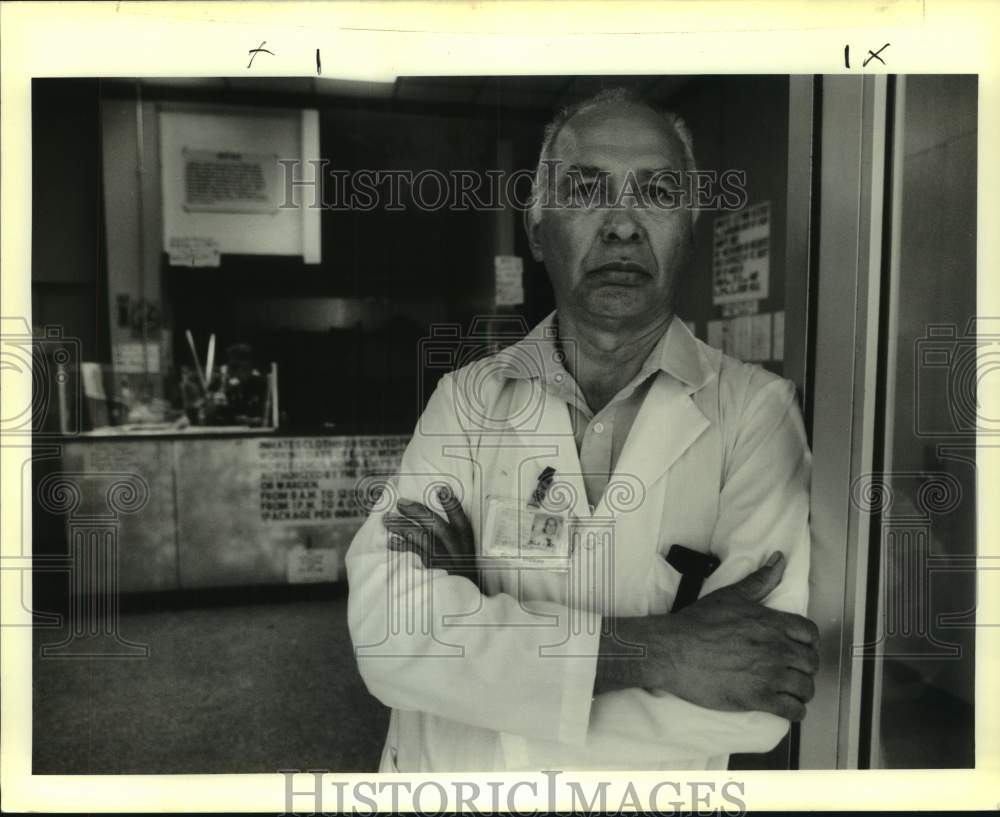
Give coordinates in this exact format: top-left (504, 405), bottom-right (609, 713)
top-left (601, 373), bottom-right (709, 513)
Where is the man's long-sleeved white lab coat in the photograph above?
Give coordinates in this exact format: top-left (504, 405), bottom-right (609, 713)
top-left (347, 316), bottom-right (810, 772)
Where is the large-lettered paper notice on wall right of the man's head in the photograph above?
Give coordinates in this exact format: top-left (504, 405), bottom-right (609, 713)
top-left (712, 201), bottom-right (771, 304)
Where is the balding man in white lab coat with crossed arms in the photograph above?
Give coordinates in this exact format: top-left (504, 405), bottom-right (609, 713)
top-left (347, 91), bottom-right (818, 772)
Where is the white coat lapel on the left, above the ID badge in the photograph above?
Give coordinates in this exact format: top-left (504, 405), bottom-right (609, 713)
top-left (511, 378), bottom-right (590, 516)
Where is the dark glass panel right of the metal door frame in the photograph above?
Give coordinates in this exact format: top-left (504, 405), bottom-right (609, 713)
top-left (867, 75), bottom-right (977, 768)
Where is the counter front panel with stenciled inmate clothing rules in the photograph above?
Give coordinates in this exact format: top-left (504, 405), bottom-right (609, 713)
top-left (56, 429), bottom-right (409, 592)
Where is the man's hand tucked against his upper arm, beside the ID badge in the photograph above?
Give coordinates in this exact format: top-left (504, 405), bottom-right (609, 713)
top-left (382, 488), bottom-right (482, 592)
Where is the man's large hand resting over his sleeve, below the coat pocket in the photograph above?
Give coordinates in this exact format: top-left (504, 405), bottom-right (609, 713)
top-left (595, 553), bottom-right (819, 721)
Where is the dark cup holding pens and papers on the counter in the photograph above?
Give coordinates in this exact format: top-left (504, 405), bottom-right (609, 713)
top-left (181, 330), bottom-right (278, 428)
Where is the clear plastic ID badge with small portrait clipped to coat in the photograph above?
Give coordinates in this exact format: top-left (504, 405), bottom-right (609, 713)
top-left (482, 496), bottom-right (570, 570)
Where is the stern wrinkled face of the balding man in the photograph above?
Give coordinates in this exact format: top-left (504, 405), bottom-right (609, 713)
top-left (527, 103), bottom-right (692, 328)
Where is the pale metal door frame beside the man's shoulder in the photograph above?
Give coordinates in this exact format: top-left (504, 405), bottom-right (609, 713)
top-left (786, 75), bottom-right (891, 769)
